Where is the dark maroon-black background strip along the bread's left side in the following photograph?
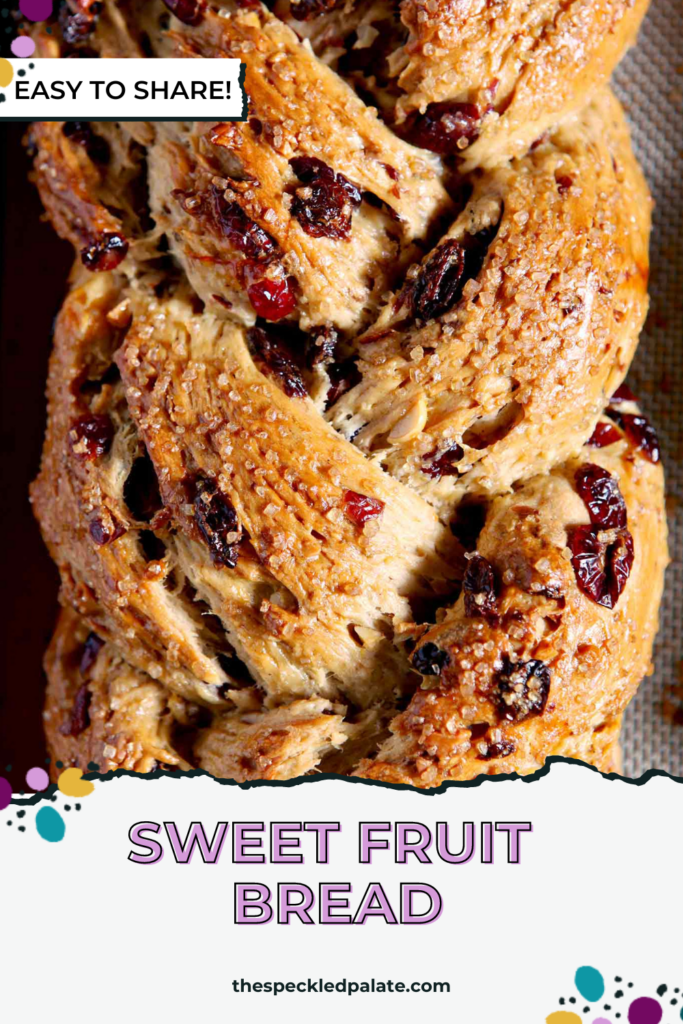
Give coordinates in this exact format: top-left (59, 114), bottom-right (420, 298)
top-left (0, 124), bottom-right (73, 770)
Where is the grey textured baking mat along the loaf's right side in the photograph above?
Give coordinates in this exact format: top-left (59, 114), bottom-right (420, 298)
top-left (614, 0), bottom-right (683, 776)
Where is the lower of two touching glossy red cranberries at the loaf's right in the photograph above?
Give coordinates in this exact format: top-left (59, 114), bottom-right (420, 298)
top-left (567, 526), bottom-right (634, 608)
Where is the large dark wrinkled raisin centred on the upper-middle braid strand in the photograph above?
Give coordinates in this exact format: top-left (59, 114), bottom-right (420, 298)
top-left (290, 157), bottom-right (361, 241)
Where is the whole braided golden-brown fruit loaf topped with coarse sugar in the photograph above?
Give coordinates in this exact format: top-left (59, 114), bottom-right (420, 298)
top-left (29, 0), bottom-right (667, 786)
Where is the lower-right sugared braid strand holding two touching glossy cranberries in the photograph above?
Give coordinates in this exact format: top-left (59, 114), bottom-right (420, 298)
top-left (356, 438), bottom-right (668, 786)
